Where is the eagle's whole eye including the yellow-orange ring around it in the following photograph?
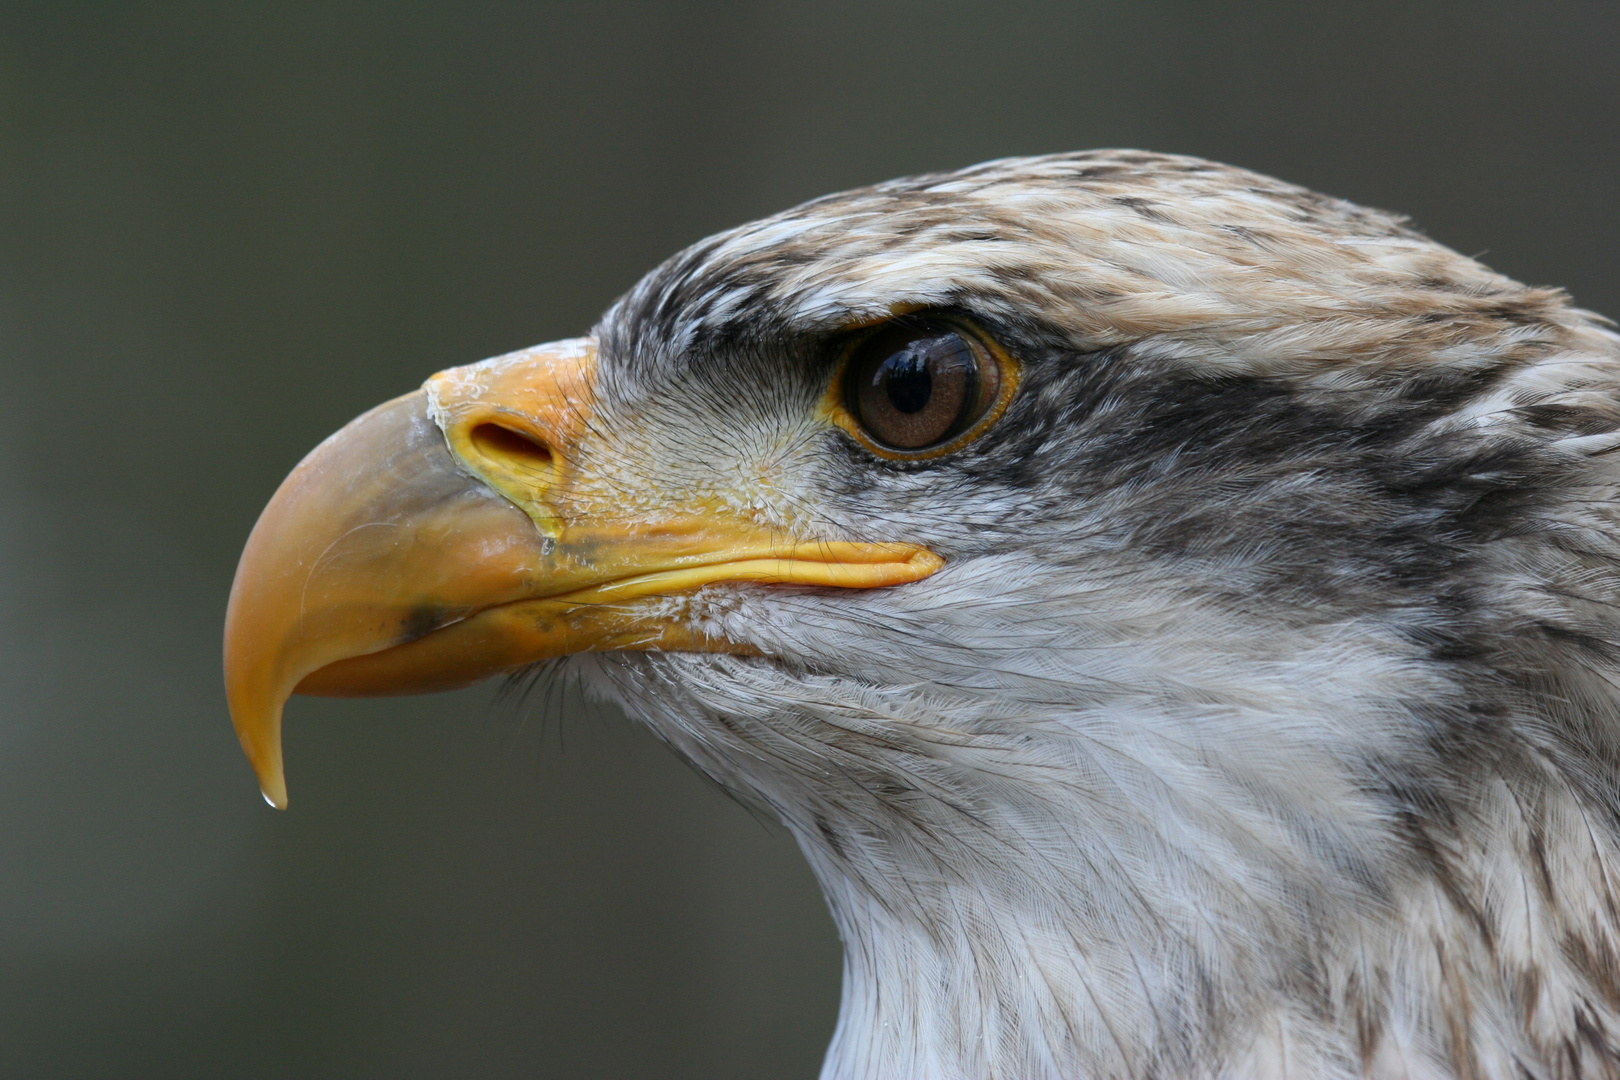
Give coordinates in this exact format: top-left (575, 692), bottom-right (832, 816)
top-left (821, 313), bottom-right (1021, 461)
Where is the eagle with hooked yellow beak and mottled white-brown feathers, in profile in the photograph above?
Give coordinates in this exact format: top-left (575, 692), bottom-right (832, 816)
top-left (225, 151), bottom-right (1620, 1080)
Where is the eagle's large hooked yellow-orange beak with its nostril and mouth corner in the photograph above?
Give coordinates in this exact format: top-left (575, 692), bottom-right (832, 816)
top-left (225, 338), bottom-right (941, 808)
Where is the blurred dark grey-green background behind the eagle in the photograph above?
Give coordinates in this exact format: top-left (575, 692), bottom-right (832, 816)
top-left (0, 0), bottom-right (1620, 1080)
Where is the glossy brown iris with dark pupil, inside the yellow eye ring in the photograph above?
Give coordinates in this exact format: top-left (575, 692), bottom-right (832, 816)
top-left (844, 321), bottom-right (1001, 450)
